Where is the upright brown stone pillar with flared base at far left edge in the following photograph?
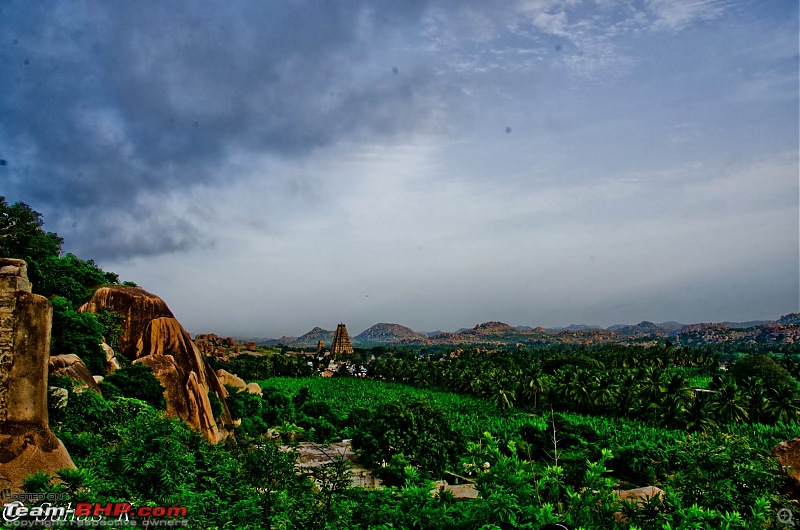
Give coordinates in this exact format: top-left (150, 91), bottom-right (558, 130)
top-left (0, 258), bottom-right (75, 492)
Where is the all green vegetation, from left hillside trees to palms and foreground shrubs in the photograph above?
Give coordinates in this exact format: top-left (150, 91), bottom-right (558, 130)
top-left (0, 198), bottom-right (799, 529)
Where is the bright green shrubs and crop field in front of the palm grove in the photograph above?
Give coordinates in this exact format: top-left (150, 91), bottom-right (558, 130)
top-left (21, 372), bottom-right (794, 530)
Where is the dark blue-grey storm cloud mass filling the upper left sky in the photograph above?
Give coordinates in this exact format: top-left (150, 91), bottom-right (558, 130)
top-left (0, 0), bottom-right (435, 258)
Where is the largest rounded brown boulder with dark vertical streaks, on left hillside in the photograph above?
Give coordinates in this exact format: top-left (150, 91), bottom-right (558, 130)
top-left (79, 286), bottom-right (233, 443)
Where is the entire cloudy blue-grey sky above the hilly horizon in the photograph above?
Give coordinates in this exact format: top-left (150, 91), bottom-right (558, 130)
top-left (0, 0), bottom-right (800, 337)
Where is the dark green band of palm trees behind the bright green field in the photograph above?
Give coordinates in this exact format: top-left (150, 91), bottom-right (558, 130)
top-left (370, 344), bottom-right (800, 431)
